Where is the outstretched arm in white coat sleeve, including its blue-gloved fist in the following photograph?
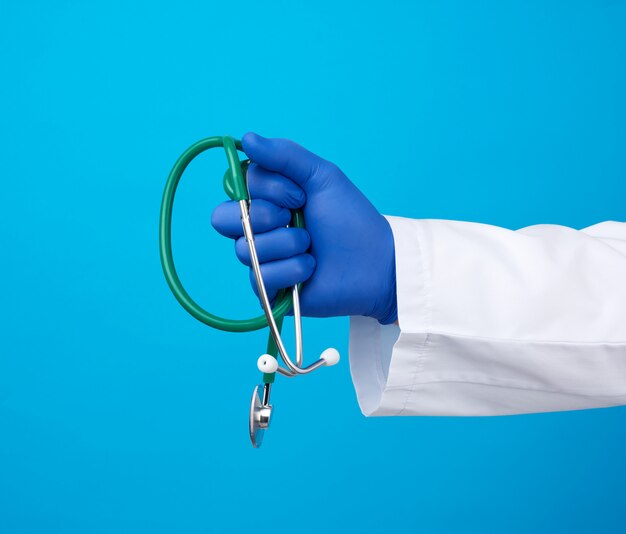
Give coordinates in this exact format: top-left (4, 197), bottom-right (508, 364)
top-left (212, 134), bottom-right (626, 415)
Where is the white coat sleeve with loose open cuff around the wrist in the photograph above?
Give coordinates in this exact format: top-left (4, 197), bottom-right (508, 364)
top-left (350, 217), bottom-right (626, 415)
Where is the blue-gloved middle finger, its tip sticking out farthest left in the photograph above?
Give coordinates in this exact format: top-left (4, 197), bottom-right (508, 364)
top-left (211, 199), bottom-right (291, 238)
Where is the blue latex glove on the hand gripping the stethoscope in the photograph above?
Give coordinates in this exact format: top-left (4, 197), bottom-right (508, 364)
top-left (211, 133), bottom-right (397, 324)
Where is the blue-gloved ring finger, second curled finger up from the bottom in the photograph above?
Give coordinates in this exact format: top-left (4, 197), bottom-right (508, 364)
top-left (235, 228), bottom-right (311, 267)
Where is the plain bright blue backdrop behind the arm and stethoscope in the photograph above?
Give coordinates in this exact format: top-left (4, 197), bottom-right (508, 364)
top-left (0, 0), bottom-right (626, 534)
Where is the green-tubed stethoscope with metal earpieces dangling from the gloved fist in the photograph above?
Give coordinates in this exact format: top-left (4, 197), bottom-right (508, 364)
top-left (159, 136), bottom-right (339, 447)
